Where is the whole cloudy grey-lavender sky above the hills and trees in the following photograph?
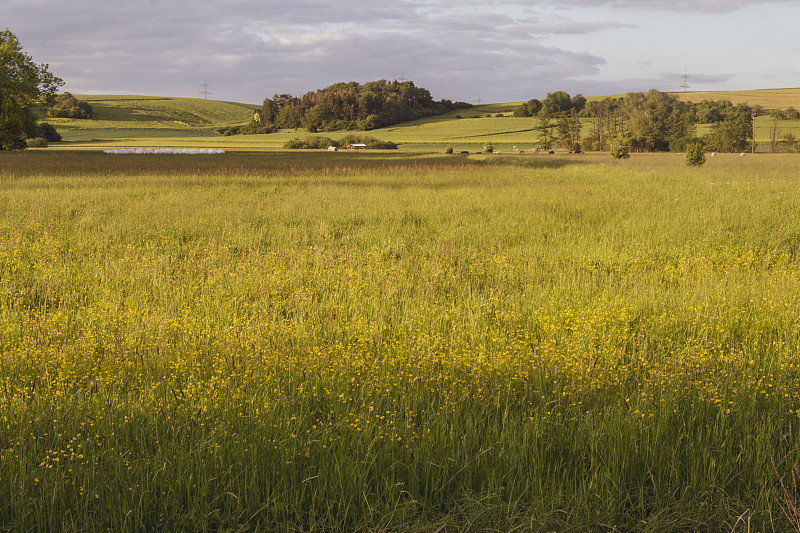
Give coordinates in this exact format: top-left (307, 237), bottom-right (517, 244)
top-left (0, 0), bottom-right (800, 104)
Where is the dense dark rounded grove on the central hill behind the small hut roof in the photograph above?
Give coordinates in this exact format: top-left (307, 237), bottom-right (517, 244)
top-left (223, 80), bottom-right (472, 134)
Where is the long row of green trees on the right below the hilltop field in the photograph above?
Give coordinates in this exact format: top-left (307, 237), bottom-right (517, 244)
top-left (514, 89), bottom-right (800, 152)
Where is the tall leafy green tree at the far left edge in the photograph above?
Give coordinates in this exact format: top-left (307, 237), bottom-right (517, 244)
top-left (0, 30), bottom-right (64, 150)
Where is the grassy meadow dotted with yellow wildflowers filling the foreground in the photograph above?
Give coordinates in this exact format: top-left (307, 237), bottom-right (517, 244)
top-left (0, 151), bottom-right (800, 532)
